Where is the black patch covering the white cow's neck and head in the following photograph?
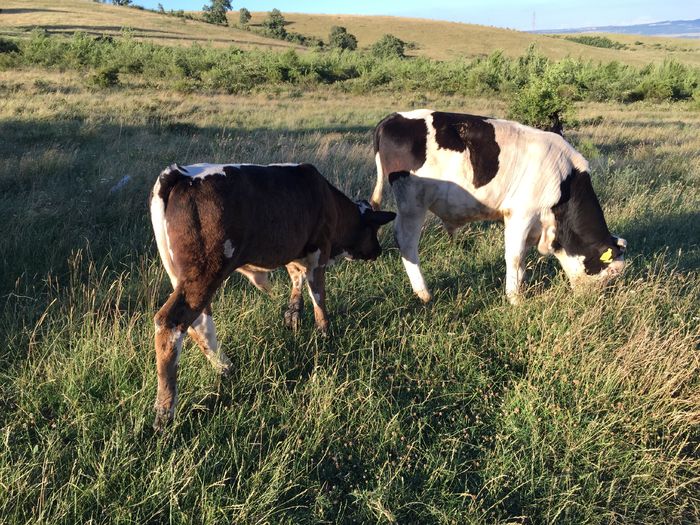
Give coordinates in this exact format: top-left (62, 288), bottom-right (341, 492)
top-left (552, 170), bottom-right (622, 275)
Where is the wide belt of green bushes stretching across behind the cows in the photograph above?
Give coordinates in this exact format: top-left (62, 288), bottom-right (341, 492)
top-left (9, 30), bottom-right (700, 104)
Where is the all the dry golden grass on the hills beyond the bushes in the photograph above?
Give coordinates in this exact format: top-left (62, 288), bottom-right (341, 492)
top-left (0, 0), bottom-right (700, 66)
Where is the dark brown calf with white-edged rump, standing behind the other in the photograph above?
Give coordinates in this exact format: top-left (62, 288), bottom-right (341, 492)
top-left (150, 164), bottom-right (396, 429)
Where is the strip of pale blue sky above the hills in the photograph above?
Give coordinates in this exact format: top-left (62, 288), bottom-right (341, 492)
top-left (134, 0), bottom-right (700, 31)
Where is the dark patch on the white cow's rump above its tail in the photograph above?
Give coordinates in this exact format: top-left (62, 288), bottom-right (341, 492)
top-left (374, 113), bottom-right (428, 173)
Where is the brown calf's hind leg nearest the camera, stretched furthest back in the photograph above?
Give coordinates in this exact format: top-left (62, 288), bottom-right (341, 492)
top-left (153, 282), bottom-right (215, 430)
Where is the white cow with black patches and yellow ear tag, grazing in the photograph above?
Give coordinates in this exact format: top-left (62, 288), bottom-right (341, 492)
top-left (371, 109), bottom-right (627, 304)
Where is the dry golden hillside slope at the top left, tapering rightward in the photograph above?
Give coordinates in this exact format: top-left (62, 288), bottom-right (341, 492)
top-left (0, 0), bottom-right (298, 49)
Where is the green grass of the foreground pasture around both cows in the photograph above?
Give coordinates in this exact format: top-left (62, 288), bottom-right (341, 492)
top-left (0, 69), bottom-right (700, 523)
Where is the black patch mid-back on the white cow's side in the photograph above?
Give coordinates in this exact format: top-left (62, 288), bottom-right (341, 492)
top-left (433, 111), bottom-right (501, 188)
